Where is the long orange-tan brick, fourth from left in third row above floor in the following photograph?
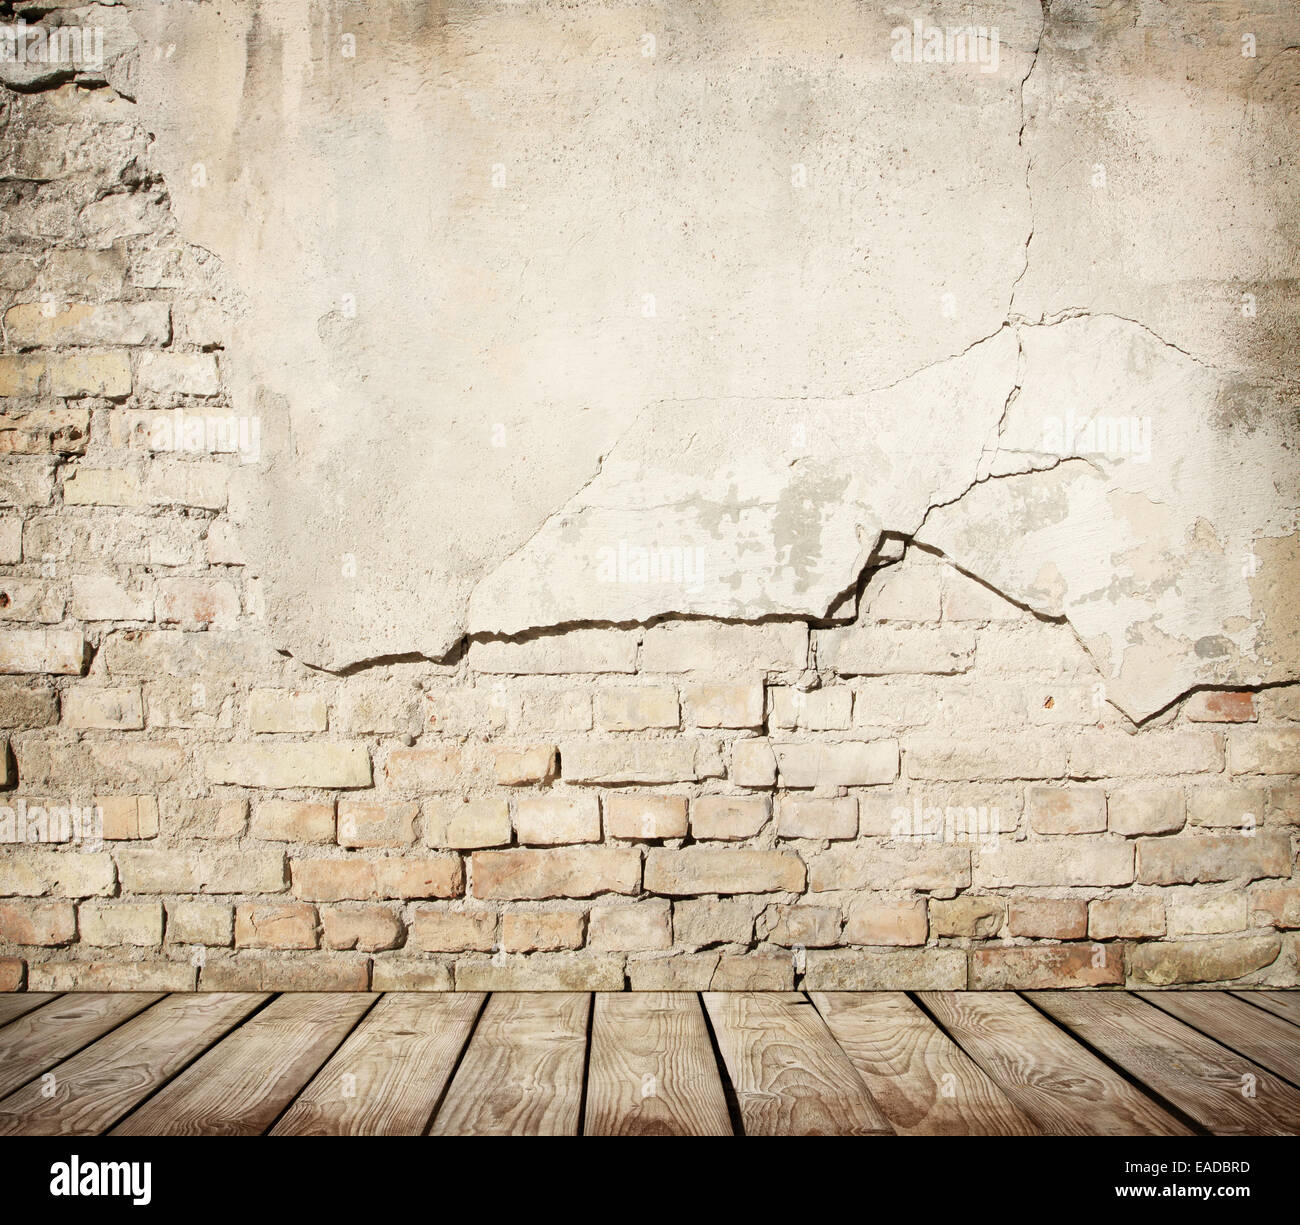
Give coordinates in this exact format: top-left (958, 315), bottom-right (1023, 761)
top-left (471, 847), bottom-right (641, 899)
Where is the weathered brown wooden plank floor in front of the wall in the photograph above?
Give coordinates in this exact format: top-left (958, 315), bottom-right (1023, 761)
top-left (0, 991), bottom-right (1300, 1135)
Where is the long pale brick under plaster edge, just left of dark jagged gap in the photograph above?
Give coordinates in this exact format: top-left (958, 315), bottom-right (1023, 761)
top-left (641, 620), bottom-right (809, 676)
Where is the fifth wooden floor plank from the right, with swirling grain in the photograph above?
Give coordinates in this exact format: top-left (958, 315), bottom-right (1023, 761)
top-left (813, 991), bottom-right (1039, 1135)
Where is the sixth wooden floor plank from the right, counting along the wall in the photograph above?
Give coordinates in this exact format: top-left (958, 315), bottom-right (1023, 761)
top-left (705, 991), bottom-right (893, 1135)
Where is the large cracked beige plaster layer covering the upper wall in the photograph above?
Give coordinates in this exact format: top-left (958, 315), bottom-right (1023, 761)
top-left (106, 0), bottom-right (1300, 720)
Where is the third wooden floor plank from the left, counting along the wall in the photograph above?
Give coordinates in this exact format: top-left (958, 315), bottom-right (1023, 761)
top-left (0, 994), bottom-right (267, 1135)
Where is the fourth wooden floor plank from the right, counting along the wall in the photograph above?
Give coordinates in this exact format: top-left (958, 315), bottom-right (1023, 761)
top-left (918, 991), bottom-right (1193, 1135)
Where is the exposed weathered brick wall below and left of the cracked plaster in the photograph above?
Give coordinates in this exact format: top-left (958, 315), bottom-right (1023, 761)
top-left (0, 82), bottom-right (1300, 991)
